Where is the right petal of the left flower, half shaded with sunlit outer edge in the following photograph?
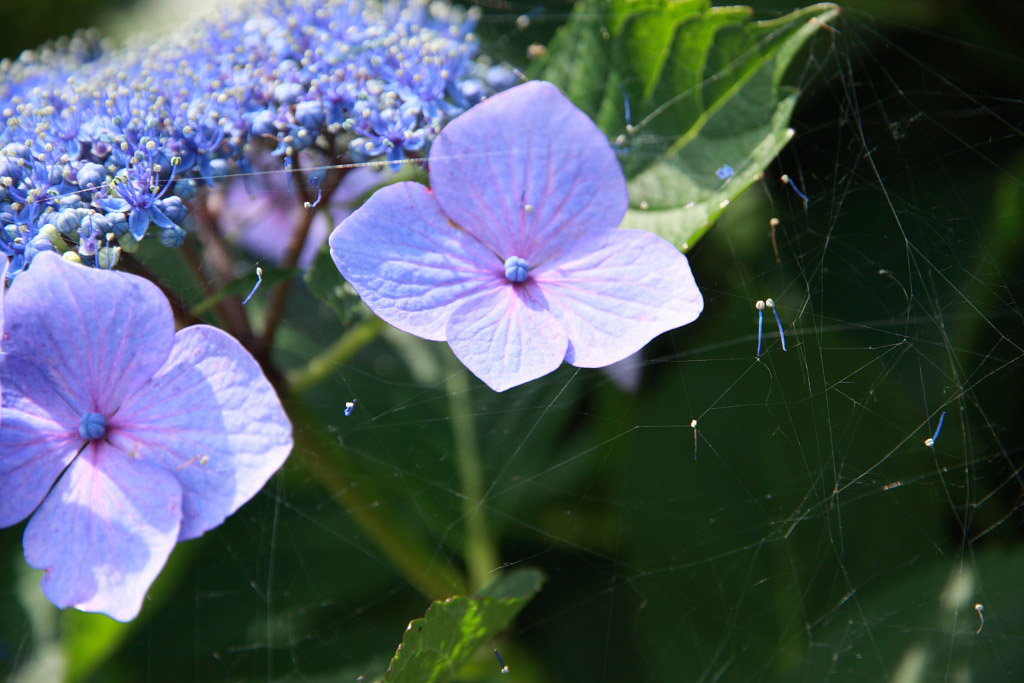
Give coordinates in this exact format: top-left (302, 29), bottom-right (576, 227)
top-left (109, 325), bottom-right (292, 541)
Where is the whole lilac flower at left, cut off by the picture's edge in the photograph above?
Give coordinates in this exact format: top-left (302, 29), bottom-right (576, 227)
top-left (0, 253), bottom-right (292, 621)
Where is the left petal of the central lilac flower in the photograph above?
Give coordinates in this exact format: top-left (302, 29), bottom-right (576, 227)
top-left (329, 182), bottom-right (505, 341)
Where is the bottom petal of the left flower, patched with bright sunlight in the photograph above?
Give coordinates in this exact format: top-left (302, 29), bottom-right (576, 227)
top-left (24, 441), bottom-right (181, 622)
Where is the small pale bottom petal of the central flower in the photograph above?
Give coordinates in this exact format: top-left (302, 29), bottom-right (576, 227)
top-left (447, 285), bottom-right (568, 391)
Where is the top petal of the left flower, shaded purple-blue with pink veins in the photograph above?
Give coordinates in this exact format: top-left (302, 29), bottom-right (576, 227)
top-left (4, 252), bottom-right (174, 417)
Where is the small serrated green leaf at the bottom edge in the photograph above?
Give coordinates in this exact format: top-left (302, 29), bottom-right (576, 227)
top-left (384, 567), bottom-right (544, 683)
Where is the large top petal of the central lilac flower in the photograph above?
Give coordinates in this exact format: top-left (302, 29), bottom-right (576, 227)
top-left (430, 81), bottom-right (628, 263)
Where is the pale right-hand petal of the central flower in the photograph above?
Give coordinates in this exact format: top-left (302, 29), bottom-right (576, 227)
top-left (532, 229), bottom-right (703, 368)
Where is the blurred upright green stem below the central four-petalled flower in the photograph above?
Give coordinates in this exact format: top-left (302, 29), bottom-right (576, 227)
top-left (444, 353), bottom-right (498, 592)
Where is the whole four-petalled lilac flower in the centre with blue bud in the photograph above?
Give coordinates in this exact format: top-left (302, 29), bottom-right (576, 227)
top-left (329, 82), bottom-right (703, 391)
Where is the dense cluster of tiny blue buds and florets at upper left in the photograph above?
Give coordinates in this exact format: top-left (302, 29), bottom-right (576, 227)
top-left (0, 0), bottom-right (488, 276)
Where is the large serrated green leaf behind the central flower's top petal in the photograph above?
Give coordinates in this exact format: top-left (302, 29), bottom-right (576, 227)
top-left (532, 0), bottom-right (839, 251)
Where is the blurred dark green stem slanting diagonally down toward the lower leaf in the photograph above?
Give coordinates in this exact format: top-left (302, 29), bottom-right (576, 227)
top-left (286, 398), bottom-right (465, 600)
